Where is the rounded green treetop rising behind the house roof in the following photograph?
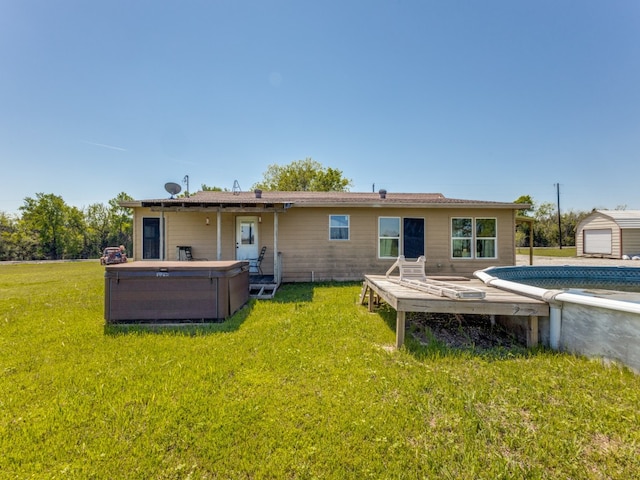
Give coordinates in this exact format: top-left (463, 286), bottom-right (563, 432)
top-left (252, 158), bottom-right (353, 192)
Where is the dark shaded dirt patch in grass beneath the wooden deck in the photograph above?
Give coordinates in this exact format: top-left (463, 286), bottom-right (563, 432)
top-left (407, 312), bottom-right (525, 350)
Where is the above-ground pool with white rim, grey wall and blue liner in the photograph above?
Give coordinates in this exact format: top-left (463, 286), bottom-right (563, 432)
top-left (474, 266), bottom-right (640, 374)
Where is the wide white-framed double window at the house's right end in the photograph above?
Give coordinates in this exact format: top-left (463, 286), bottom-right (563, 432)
top-left (451, 218), bottom-right (497, 258)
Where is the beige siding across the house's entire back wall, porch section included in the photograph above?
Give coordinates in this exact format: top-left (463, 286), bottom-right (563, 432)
top-left (134, 206), bottom-right (515, 282)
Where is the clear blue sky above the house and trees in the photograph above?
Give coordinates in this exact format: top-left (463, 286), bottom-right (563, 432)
top-left (0, 0), bottom-right (640, 213)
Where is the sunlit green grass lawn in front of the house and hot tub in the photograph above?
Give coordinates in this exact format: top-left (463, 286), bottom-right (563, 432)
top-left (0, 262), bottom-right (640, 479)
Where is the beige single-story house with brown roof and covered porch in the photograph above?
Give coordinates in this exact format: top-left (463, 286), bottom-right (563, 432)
top-left (120, 190), bottom-right (527, 282)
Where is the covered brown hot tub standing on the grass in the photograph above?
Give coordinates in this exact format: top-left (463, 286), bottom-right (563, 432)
top-left (104, 261), bottom-right (249, 323)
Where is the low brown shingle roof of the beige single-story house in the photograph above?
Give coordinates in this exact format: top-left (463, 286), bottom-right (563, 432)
top-left (120, 191), bottom-right (528, 210)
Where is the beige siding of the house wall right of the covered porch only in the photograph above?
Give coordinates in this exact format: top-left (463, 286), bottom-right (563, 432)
top-left (279, 208), bottom-right (515, 281)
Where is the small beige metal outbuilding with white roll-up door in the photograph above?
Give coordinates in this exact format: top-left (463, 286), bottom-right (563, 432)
top-left (576, 210), bottom-right (640, 258)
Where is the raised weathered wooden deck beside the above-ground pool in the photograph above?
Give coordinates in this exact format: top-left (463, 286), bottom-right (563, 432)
top-left (360, 275), bottom-right (549, 348)
